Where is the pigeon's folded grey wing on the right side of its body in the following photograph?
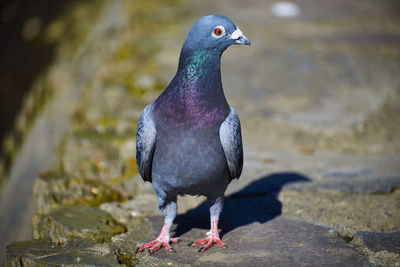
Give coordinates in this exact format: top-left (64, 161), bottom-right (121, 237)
top-left (219, 107), bottom-right (243, 179)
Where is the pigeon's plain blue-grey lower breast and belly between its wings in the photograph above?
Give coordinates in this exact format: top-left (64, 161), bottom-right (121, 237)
top-left (152, 126), bottom-right (229, 196)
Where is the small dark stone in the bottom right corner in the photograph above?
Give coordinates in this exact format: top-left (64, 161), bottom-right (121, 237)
top-left (352, 231), bottom-right (400, 266)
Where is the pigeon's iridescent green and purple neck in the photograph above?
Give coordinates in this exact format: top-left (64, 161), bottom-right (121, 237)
top-left (154, 49), bottom-right (229, 131)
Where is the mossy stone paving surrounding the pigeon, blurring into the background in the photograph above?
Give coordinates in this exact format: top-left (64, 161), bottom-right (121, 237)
top-left (0, 0), bottom-right (400, 266)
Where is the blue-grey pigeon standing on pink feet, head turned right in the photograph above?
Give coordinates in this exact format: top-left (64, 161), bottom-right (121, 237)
top-left (136, 15), bottom-right (250, 254)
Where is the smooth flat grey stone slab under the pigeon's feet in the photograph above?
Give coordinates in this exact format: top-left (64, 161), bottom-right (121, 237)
top-left (130, 217), bottom-right (369, 266)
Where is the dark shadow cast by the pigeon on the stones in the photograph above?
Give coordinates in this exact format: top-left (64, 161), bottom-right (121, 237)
top-left (174, 172), bottom-right (310, 238)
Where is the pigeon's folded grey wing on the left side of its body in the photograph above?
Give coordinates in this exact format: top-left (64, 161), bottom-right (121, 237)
top-left (136, 104), bottom-right (157, 182)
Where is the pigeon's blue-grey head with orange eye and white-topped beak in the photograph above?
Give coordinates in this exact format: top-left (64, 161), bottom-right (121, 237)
top-left (184, 15), bottom-right (250, 52)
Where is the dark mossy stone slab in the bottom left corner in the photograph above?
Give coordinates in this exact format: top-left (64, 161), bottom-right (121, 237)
top-left (5, 239), bottom-right (118, 267)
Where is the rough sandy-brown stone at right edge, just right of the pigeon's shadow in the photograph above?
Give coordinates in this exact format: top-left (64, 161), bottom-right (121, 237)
top-left (278, 189), bottom-right (400, 240)
